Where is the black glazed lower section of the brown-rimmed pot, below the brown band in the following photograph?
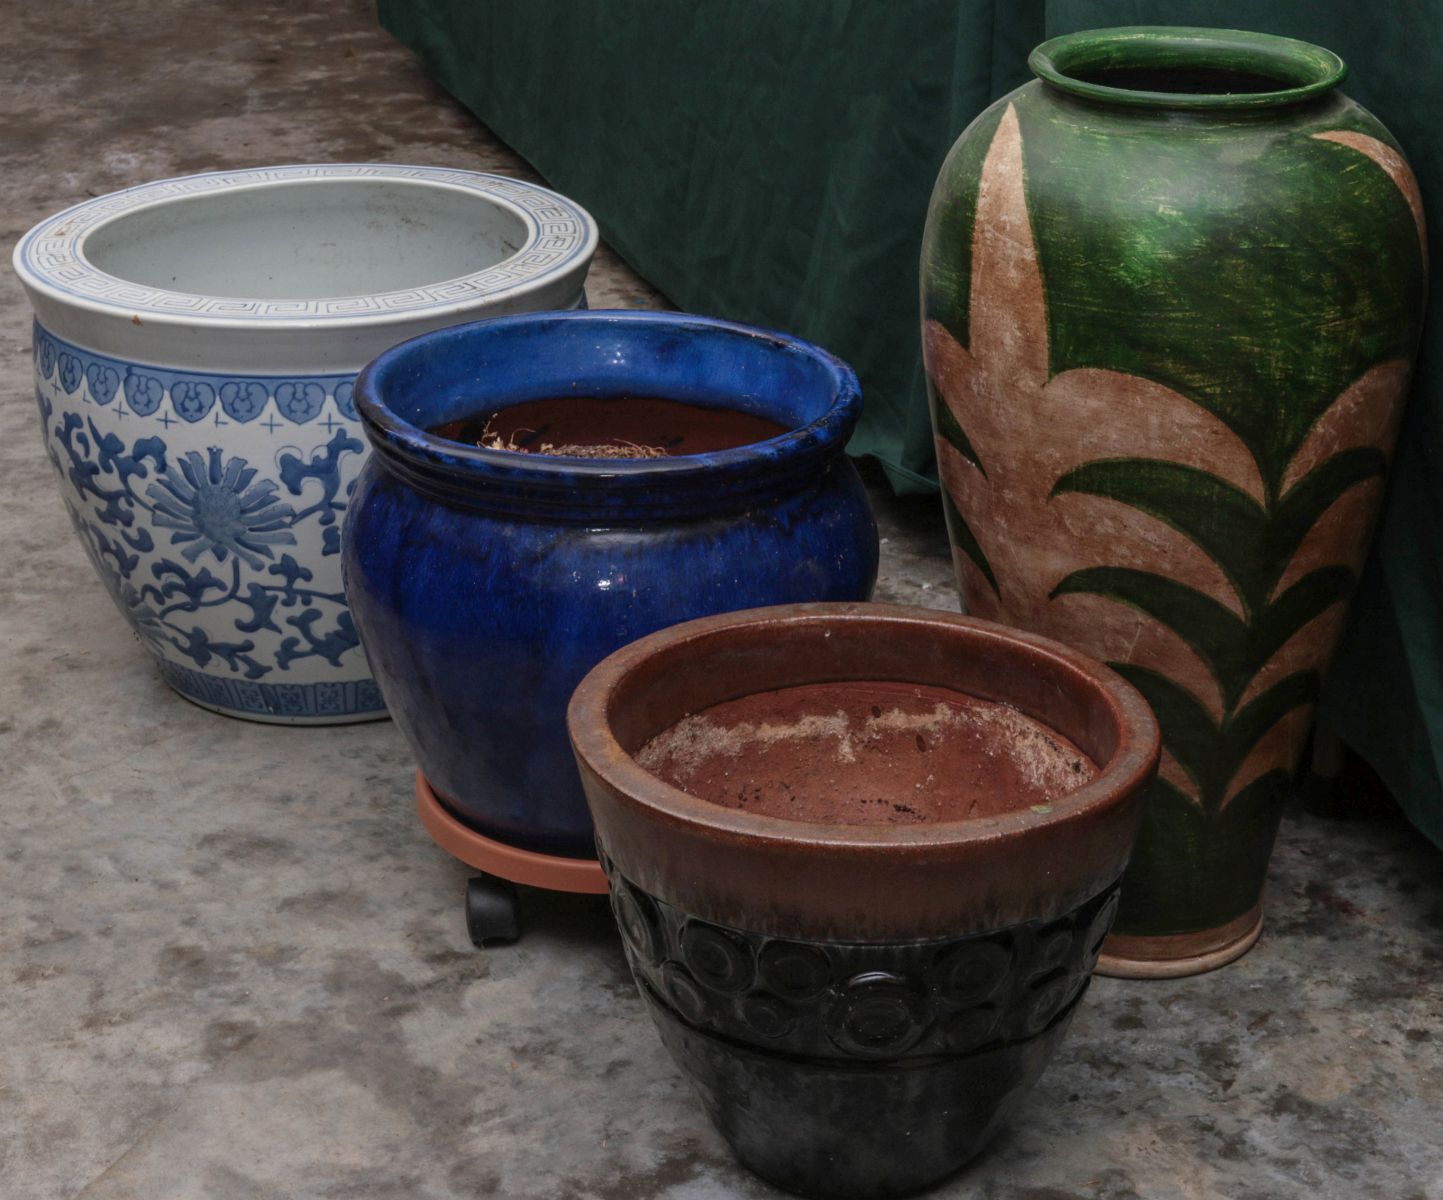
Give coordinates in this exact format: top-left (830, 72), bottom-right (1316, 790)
top-left (603, 858), bottom-right (1117, 1197)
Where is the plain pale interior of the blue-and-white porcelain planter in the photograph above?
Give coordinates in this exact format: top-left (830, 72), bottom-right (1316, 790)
top-left (84, 179), bottom-right (527, 300)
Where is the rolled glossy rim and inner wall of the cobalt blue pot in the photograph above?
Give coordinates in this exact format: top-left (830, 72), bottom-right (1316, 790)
top-left (355, 310), bottom-right (861, 519)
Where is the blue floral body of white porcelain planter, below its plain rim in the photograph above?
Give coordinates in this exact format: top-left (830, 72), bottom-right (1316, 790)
top-left (35, 327), bottom-right (381, 718)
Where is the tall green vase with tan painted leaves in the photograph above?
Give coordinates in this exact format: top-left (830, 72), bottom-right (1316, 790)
top-left (922, 29), bottom-right (1426, 975)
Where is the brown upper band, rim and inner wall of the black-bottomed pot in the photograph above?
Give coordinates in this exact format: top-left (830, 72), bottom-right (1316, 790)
top-left (567, 604), bottom-right (1159, 940)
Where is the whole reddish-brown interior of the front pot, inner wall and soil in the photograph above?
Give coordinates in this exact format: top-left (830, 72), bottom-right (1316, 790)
top-left (609, 617), bottom-right (1124, 825)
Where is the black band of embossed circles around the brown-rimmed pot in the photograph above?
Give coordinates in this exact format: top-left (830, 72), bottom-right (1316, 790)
top-left (602, 854), bottom-right (1115, 1062)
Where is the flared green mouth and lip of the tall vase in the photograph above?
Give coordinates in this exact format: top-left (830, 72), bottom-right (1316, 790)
top-left (1027, 25), bottom-right (1348, 110)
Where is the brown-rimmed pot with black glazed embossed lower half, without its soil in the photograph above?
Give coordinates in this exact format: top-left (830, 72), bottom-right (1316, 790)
top-left (569, 604), bottom-right (1159, 1196)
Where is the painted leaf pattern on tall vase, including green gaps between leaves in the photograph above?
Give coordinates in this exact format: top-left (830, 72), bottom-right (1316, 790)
top-left (924, 104), bottom-right (1421, 819)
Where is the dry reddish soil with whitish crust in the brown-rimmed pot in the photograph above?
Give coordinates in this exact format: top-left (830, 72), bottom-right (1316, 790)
top-left (636, 681), bottom-right (1097, 825)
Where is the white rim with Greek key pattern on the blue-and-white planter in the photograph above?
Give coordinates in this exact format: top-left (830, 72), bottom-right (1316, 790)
top-left (13, 163), bottom-right (599, 336)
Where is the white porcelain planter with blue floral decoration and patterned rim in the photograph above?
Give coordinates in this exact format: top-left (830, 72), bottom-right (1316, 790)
top-left (14, 164), bottom-right (596, 724)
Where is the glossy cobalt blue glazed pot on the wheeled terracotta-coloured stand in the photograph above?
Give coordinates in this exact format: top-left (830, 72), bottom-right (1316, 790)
top-left (343, 304), bottom-right (877, 873)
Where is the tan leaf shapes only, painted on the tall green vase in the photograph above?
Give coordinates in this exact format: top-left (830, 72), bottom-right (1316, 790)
top-left (922, 104), bottom-right (1423, 802)
